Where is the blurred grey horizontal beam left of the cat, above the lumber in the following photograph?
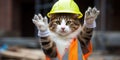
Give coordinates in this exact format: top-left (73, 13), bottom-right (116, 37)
top-left (0, 37), bottom-right (40, 48)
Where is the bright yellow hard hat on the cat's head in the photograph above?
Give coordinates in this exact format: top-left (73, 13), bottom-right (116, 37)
top-left (47, 0), bottom-right (83, 18)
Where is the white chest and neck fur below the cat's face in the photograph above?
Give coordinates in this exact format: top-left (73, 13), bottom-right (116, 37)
top-left (50, 27), bottom-right (81, 56)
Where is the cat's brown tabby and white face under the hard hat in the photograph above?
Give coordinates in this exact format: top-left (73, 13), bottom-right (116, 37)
top-left (49, 15), bottom-right (80, 36)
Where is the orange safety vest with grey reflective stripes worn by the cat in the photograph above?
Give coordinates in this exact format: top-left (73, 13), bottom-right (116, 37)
top-left (46, 38), bottom-right (92, 60)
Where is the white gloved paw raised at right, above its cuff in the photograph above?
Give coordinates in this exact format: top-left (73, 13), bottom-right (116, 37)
top-left (84, 7), bottom-right (100, 24)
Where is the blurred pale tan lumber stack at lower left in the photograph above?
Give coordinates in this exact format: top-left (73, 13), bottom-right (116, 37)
top-left (1, 47), bottom-right (45, 60)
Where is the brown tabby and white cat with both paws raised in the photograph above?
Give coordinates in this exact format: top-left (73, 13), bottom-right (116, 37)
top-left (32, 7), bottom-right (99, 57)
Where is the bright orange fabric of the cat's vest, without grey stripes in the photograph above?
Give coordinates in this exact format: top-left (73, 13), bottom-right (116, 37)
top-left (46, 38), bottom-right (92, 60)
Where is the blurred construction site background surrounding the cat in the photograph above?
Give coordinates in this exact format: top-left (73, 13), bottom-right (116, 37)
top-left (0, 0), bottom-right (120, 60)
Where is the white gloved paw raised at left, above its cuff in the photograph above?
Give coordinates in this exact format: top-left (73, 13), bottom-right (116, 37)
top-left (32, 14), bottom-right (48, 31)
